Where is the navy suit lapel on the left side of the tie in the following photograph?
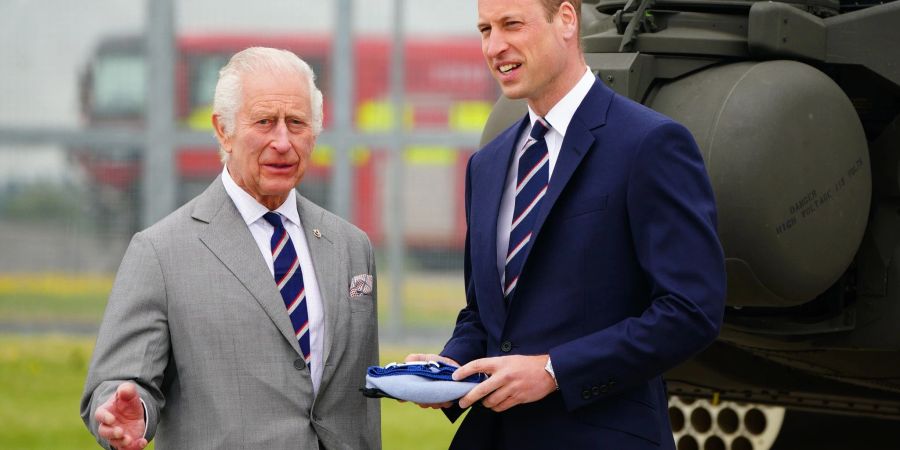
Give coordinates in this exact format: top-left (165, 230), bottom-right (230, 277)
top-left (470, 115), bottom-right (528, 317)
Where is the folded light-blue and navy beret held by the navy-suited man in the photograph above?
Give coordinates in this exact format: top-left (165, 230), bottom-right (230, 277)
top-left (362, 361), bottom-right (487, 403)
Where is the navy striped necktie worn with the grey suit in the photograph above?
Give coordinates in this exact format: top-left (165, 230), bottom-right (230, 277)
top-left (263, 211), bottom-right (310, 367)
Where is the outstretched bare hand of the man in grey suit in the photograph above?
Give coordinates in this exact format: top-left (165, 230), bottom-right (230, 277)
top-left (94, 382), bottom-right (147, 450)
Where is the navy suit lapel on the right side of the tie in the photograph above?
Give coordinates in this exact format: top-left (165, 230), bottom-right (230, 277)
top-left (512, 78), bottom-right (613, 303)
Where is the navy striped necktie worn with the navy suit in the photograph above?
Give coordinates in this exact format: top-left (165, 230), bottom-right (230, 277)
top-left (503, 118), bottom-right (550, 302)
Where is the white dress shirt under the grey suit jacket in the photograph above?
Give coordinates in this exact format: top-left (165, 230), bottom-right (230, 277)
top-left (222, 167), bottom-right (325, 392)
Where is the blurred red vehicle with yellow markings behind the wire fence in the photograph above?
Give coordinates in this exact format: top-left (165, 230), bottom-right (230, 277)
top-left (79, 35), bottom-right (499, 252)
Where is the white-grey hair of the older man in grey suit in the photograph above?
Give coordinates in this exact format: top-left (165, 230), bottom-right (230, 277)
top-left (213, 47), bottom-right (323, 162)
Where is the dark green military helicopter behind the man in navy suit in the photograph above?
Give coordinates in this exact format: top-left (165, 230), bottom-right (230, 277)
top-left (483, 0), bottom-right (900, 450)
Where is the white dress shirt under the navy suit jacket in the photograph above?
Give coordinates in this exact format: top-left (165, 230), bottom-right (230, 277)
top-left (497, 67), bottom-right (596, 289)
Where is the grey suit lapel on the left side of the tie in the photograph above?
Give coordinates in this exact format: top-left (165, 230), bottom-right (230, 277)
top-left (192, 178), bottom-right (300, 355)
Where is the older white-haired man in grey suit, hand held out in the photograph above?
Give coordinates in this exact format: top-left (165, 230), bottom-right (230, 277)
top-left (81, 48), bottom-right (380, 450)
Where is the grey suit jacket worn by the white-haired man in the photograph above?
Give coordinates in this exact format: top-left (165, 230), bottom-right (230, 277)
top-left (81, 178), bottom-right (381, 450)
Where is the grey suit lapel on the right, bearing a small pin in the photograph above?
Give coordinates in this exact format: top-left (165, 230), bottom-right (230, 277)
top-left (297, 194), bottom-right (349, 370)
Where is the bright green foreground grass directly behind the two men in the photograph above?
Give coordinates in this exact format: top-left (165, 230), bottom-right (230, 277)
top-left (0, 335), bottom-right (458, 450)
